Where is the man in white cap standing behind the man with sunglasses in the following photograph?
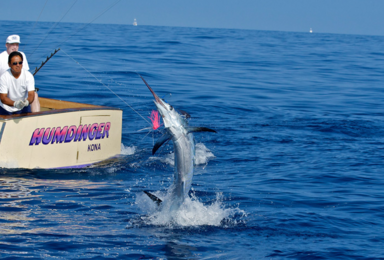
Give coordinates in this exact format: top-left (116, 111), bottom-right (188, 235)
top-left (0, 34), bottom-right (40, 112)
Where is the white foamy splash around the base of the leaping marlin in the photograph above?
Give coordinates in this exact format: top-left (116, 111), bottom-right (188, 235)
top-left (136, 193), bottom-right (246, 228)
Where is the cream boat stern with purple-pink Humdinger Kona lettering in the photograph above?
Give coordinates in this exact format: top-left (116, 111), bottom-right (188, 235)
top-left (0, 97), bottom-right (122, 168)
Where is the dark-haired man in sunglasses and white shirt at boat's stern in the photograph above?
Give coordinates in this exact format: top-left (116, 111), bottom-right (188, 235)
top-left (0, 51), bottom-right (35, 115)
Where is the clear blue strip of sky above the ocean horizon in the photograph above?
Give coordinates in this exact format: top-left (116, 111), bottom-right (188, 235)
top-left (0, 0), bottom-right (384, 35)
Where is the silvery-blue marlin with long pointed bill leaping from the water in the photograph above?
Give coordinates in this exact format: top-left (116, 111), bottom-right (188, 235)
top-left (139, 75), bottom-right (216, 210)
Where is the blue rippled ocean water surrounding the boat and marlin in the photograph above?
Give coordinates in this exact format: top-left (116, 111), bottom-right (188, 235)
top-left (0, 21), bottom-right (384, 259)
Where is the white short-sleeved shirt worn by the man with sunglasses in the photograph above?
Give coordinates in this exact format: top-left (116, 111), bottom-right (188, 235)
top-left (0, 68), bottom-right (35, 113)
